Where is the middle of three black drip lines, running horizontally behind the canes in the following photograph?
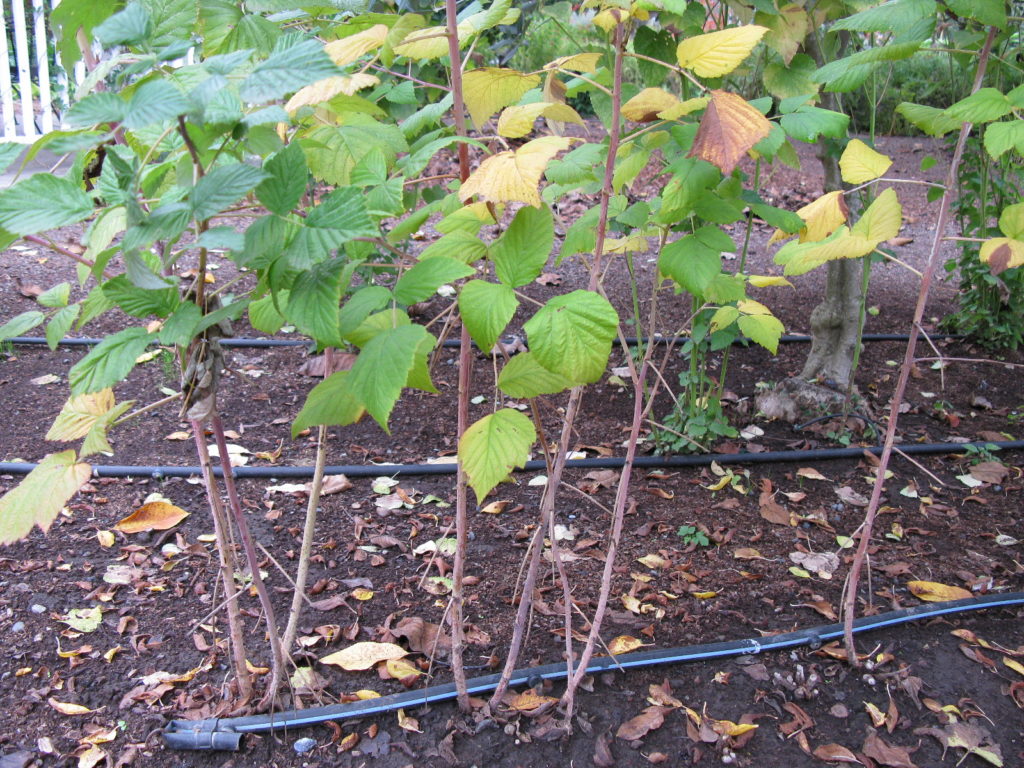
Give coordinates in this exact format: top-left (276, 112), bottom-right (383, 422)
top-left (0, 440), bottom-right (1024, 480)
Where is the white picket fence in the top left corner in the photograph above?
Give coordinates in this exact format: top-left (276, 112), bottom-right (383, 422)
top-left (0, 0), bottom-right (75, 143)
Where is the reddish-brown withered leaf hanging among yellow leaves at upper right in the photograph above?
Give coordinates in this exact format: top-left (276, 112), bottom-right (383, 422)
top-left (689, 90), bottom-right (771, 175)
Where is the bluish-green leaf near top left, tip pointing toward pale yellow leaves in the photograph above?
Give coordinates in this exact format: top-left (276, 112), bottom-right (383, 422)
top-left (241, 33), bottom-right (341, 103)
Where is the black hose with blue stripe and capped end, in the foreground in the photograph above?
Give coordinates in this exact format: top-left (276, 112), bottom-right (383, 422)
top-left (164, 592), bottom-right (1024, 750)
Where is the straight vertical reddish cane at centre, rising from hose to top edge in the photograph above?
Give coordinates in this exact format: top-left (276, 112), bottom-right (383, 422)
top-left (444, 0), bottom-right (473, 713)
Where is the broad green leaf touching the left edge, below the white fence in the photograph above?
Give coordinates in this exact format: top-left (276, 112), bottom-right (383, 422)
top-left (0, 173), bottom-right (93, 234)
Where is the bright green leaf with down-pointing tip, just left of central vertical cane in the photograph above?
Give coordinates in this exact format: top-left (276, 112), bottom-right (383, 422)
top-left (347, 325), bottom-right (433, 434)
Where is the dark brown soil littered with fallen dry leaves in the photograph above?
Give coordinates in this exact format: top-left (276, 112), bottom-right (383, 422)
top-left (0, 138), bottom-right (1024, 768)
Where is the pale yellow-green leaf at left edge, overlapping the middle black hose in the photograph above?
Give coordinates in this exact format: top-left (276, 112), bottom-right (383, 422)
top-left (0, 451), bottom-right (92, 544)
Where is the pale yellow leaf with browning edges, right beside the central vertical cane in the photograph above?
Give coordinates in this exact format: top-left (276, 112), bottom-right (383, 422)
top-left (459, 136), bottom-right (572, 208)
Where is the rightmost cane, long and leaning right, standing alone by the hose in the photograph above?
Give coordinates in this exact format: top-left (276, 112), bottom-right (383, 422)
top-left (843, 27), bottom-right (997, 667)
